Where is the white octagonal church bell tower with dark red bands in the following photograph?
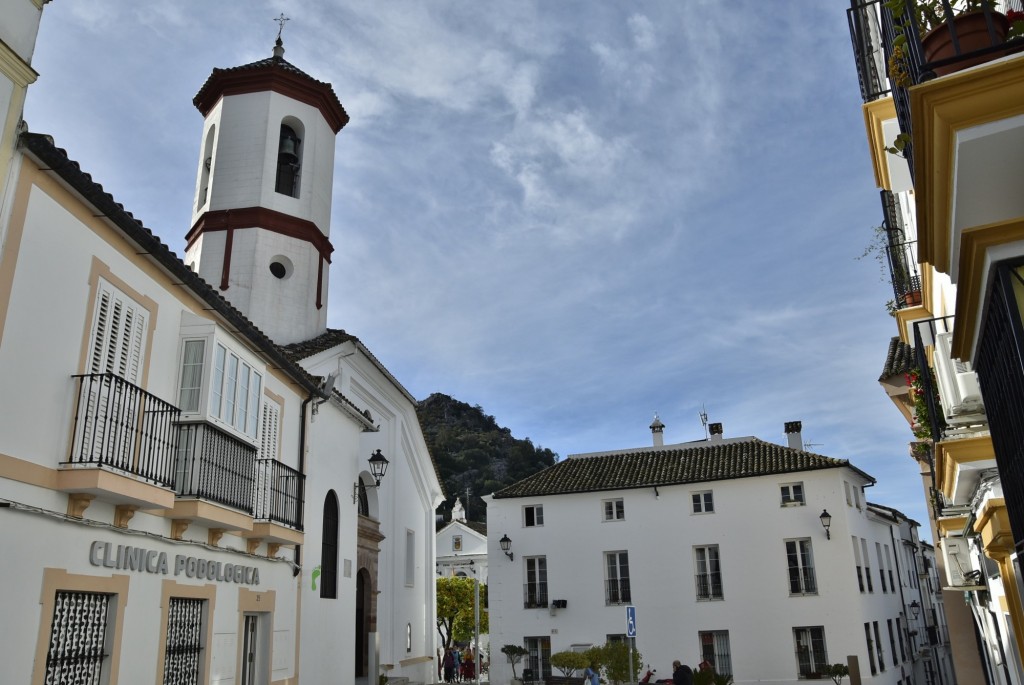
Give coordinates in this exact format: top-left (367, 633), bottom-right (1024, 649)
top-left (185, 35), bottom-right (348, 345)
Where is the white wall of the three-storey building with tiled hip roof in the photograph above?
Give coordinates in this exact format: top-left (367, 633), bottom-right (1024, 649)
top-left (487, 457), bottom-right (937, 683)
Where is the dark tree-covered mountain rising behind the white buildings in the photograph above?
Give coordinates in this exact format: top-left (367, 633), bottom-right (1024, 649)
top-left (416, 392), bottom-right (558, 521)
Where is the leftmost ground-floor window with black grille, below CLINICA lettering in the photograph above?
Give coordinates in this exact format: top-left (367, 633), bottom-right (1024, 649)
top-left (43, 590), bottom-right (113, 685)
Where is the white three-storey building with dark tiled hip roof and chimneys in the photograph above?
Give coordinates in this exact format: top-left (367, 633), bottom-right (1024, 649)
top-left (487, 419), bottom-right (953, 685)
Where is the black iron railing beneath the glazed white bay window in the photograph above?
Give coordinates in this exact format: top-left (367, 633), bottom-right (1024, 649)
top-left (175, 423), bottom-right (256, 515)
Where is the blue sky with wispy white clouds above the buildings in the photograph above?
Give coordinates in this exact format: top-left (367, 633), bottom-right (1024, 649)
top-left (25, 0), bottom-right (931, 539)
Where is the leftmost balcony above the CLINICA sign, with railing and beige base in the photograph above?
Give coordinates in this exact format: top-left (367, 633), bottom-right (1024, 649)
top-left (57, 373), bottom-right (180, 509)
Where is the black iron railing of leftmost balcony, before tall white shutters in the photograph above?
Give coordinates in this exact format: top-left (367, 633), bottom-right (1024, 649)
top-left (66, 373), bottom-right (180, 487)
